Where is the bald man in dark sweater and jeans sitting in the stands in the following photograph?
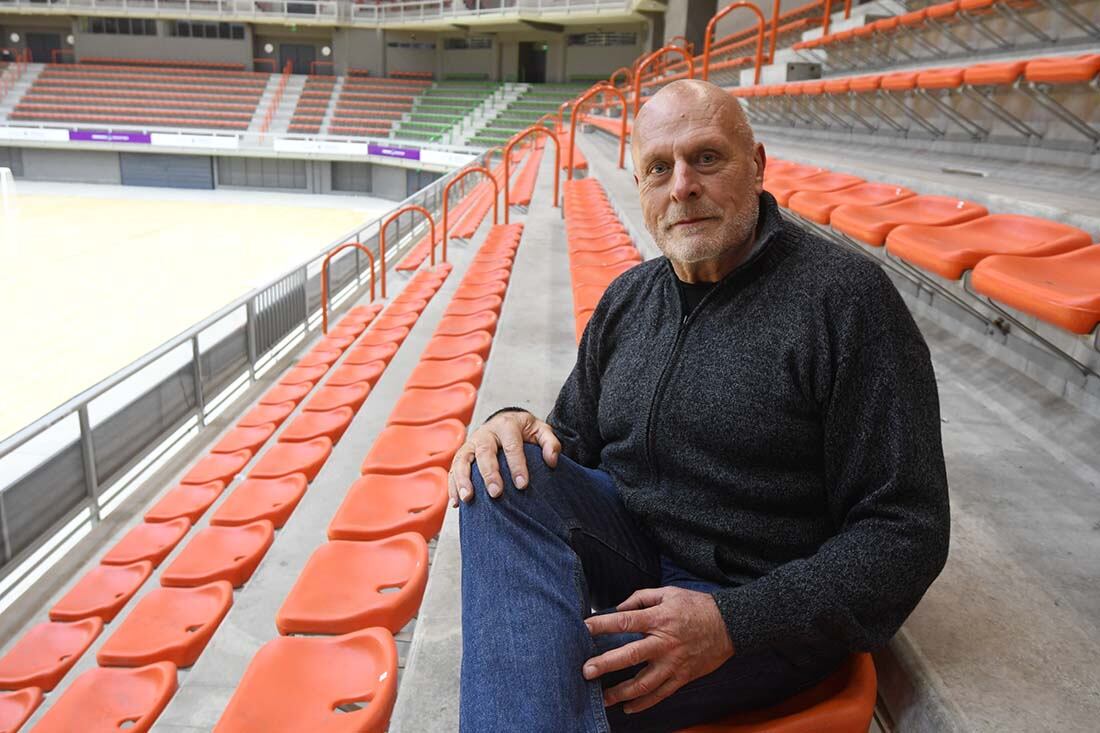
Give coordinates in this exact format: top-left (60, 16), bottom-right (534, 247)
top-left (450, 80), bottom-right (949, 733)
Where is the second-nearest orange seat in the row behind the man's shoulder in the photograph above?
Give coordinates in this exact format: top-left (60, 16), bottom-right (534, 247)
top-left (887, 214), bottom-right (1092, 280)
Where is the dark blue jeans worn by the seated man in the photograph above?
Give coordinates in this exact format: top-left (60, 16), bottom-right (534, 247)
top-left (460, 446), bottom-right (845, 733)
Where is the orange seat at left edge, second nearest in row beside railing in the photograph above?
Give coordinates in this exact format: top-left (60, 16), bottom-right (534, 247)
top-left (0, 616), bottom-right (102, 692)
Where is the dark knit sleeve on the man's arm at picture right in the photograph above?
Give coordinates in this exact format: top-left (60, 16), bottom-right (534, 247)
top-left (714, 276), bottom-right (950, 653)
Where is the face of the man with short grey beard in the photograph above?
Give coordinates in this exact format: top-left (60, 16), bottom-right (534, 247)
top-left (634, 95), bottom-right (763, 264)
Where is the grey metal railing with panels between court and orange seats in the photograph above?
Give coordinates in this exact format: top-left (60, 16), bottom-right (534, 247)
top-left (0, 148), bottom-right (486, 608)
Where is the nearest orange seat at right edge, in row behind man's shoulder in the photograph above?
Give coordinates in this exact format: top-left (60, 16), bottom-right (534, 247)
top-left (971, 244), bottom-right (1100, 336)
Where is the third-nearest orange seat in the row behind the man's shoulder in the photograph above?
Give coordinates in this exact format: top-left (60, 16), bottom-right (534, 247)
top-left (829, 196), bottom-right (989, 247)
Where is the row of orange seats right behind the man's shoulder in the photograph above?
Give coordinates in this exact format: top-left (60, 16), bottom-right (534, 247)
top-left (765, 160), bottom-right (1100, 335)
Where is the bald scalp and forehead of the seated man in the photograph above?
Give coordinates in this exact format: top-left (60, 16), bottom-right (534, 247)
top-left (630, 79), bottom-right (756, 167)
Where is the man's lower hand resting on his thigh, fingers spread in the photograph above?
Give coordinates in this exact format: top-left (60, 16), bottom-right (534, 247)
top-left (584, 588), bottom-right (734, 713)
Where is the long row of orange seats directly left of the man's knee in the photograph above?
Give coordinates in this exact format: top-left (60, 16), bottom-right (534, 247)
top-left (215, 225), bottom-right (523, 733)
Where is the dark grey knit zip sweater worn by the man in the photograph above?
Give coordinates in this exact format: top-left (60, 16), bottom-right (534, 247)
top-left (548, 194), bottom-right (949, 653)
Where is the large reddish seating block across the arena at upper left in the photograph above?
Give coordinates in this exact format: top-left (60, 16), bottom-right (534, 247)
top-left (10, 64), bottom-right (271, 130)
